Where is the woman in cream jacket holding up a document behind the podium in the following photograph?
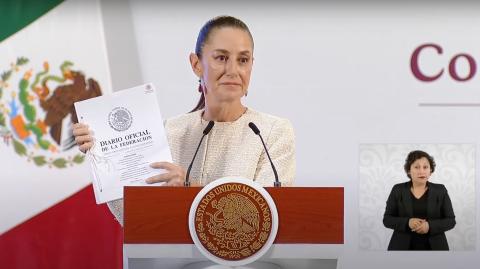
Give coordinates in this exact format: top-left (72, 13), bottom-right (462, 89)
top-left (73, 16), bottom-right (295, 223)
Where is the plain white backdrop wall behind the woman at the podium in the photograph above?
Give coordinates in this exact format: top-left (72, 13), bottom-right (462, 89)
top-left (107, 0), bottom-right (480, 268)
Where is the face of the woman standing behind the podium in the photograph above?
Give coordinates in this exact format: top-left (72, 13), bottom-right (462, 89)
top-left (199, 27), bottom-right (253, 105)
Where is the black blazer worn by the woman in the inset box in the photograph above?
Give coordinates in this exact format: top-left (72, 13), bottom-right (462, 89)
top-left (383, 181), bottom-right (456, 250)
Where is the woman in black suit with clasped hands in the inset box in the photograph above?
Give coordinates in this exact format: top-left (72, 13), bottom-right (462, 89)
top-left (383, 150), bottom-right (455, 250)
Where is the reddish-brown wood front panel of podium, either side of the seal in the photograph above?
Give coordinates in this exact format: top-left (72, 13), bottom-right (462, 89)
top-left (124, 187), bottom-right (344, 244)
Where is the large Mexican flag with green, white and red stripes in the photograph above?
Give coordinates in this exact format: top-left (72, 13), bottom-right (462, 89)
top-left (0, 0), bottom-right (122, 269)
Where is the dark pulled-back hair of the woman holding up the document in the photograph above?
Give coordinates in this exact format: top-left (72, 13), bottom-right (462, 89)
top-left (190, 16), bottom-right (253, 112)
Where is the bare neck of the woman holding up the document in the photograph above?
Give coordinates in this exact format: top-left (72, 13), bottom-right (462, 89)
top-left (203, 103), bottom-right (247, 122)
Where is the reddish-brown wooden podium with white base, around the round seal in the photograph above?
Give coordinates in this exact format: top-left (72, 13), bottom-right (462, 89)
top-left (123, 187), bottom-right (344, 269)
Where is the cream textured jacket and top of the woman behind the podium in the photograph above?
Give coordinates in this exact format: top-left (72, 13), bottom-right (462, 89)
top-left (108, 108), bottom-right (295, 225)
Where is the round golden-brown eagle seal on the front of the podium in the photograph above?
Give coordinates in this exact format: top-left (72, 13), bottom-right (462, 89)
top-left (195, 183), bottom-right (272, 261)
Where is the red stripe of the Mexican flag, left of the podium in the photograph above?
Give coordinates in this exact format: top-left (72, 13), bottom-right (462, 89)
top-left (0, 185), bottom-right (123, 269)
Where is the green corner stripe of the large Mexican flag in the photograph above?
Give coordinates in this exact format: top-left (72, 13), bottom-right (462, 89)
top-left (0, 0), bottom-right (63, 42)
